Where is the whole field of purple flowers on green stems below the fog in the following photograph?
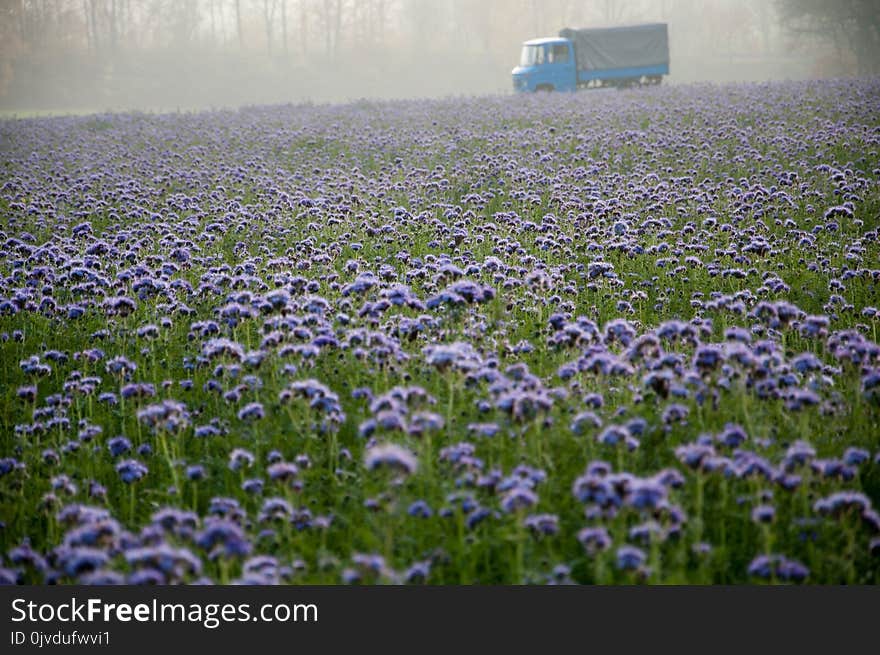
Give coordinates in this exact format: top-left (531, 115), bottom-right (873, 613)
top-left (0, 80), bottom-right (880, 584)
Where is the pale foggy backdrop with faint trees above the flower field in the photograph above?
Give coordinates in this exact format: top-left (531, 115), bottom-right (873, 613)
top-left (0, 0), bottom-right (880, 111)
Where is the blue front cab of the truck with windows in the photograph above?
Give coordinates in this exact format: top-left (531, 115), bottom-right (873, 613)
top-left (511, 37), bottom-right (577, 92)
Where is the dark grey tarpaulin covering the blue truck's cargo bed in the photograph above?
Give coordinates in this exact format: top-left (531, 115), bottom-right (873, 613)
top-left (559, 23), bottom-right (669, 70)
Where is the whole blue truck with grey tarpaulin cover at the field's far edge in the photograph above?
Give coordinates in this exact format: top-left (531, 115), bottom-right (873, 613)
top-left (512, 23), bottom-right (669, 92)
